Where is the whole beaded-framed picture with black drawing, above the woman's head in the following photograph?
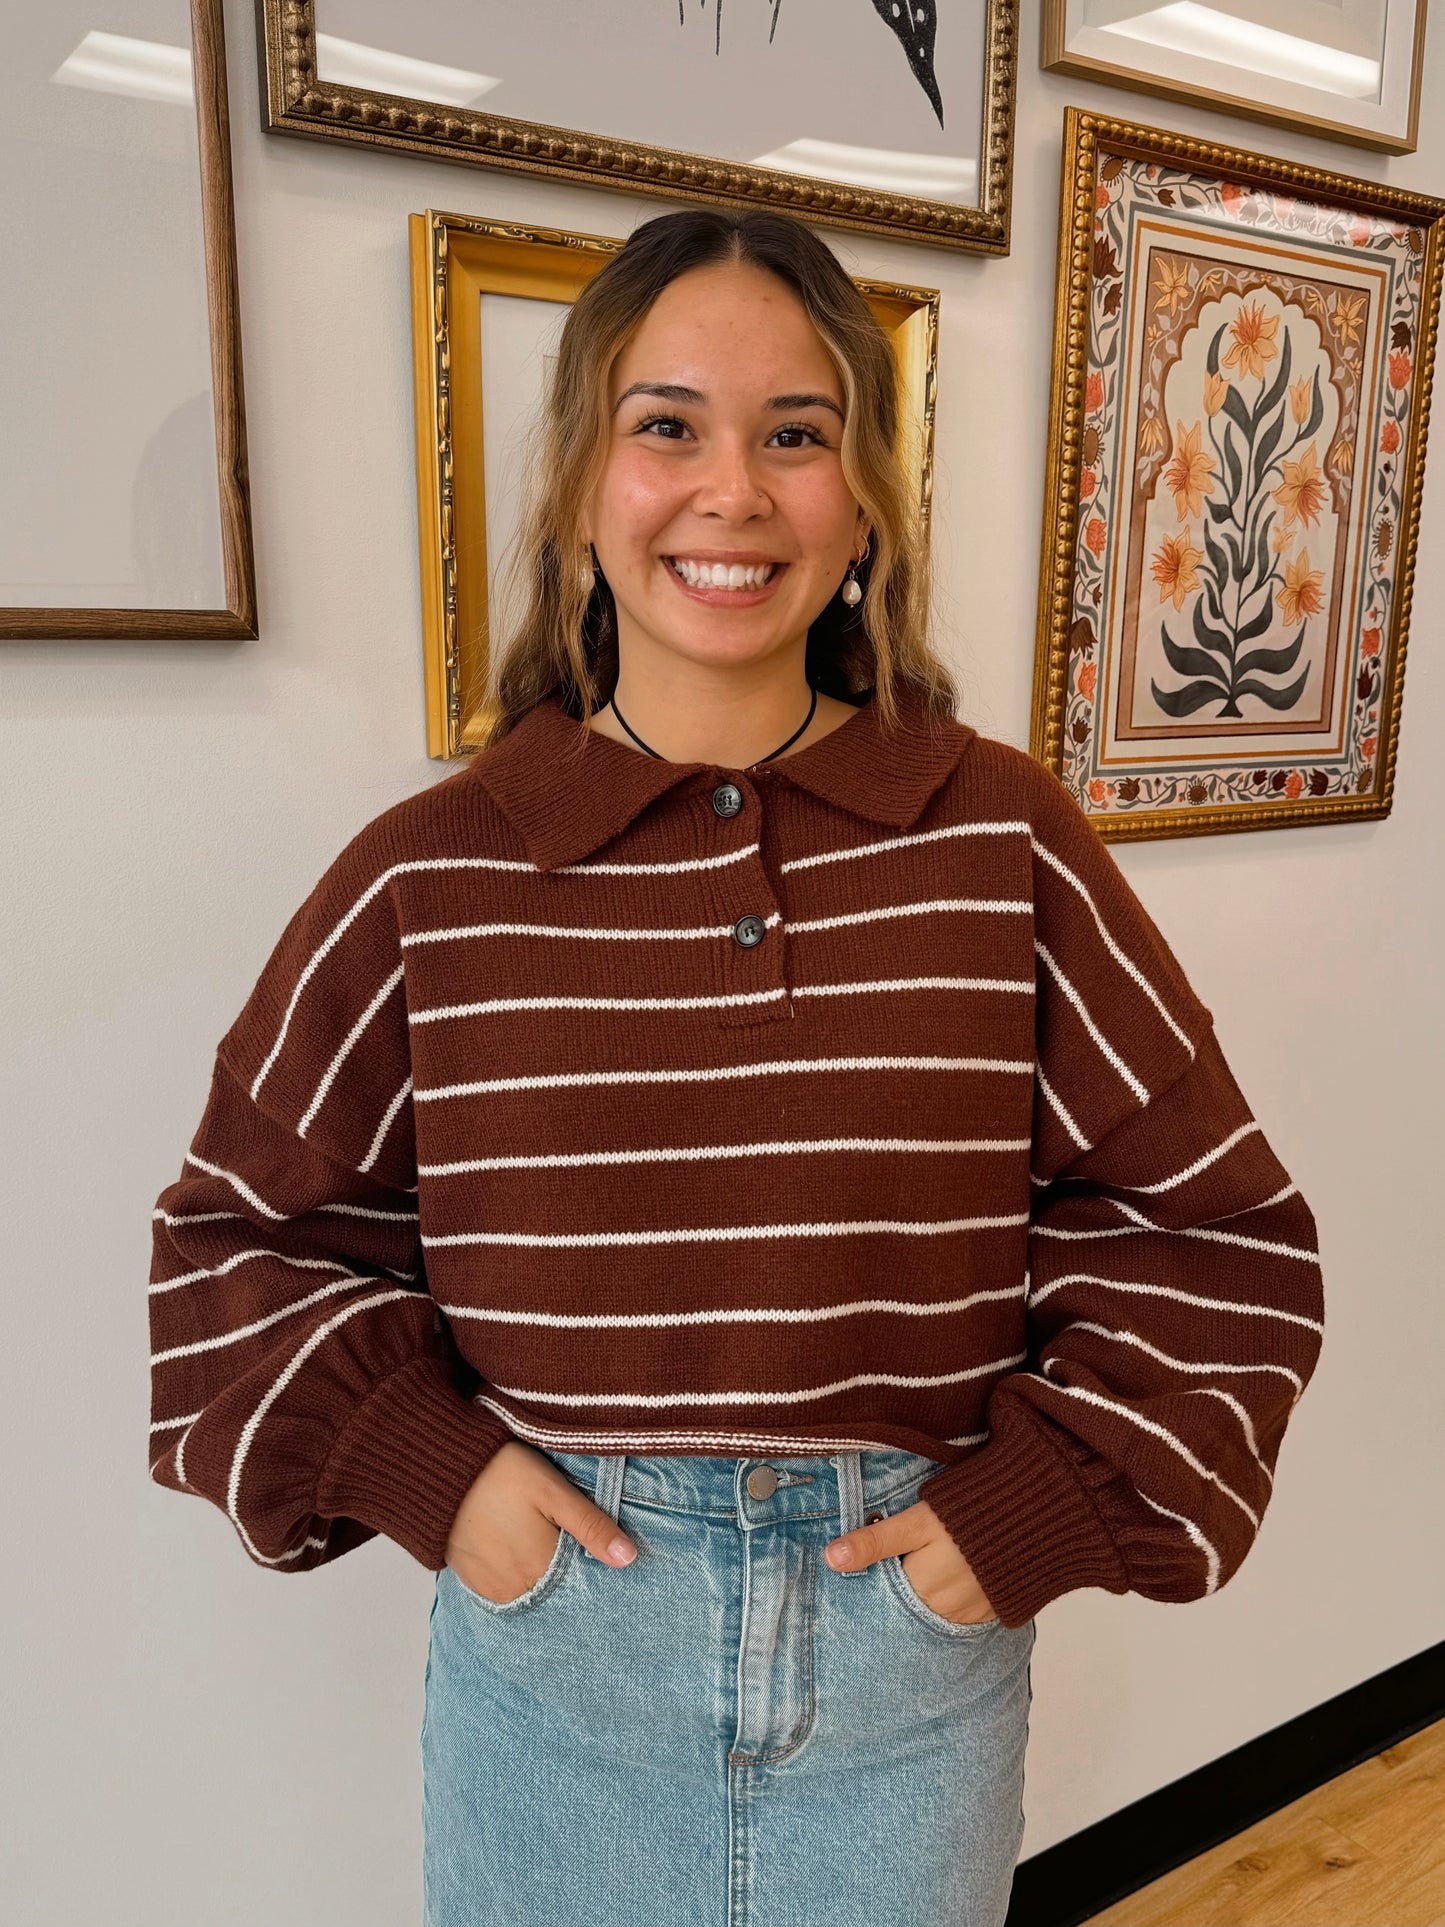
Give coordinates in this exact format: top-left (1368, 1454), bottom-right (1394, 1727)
top-left (256, 0), bottom-right (1017, 254)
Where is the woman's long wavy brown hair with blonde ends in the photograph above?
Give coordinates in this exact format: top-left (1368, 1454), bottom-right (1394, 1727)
top-left (475, 208), bottom-right (958, 748)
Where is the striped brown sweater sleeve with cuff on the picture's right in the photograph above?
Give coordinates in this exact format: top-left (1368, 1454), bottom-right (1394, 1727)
top-left (919, 771), bottom-right (1324, 1626)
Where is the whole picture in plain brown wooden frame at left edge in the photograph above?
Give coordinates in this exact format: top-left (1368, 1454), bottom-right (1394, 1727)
top-left (0, 0), bottom-right (258, 642)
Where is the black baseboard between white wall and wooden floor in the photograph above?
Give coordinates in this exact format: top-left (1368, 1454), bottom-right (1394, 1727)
top-left (1008, 1644), bottom-right (1445, 1927)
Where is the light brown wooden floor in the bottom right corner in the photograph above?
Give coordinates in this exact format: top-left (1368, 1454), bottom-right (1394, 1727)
top-left (1089, 1721), bottom-right (1445, 1927)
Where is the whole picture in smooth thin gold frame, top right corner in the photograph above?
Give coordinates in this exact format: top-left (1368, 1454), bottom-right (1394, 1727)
top-left (1038, 0), bottom-right (1426, 154)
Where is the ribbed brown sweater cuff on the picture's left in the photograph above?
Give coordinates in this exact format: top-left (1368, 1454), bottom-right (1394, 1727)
top-left (316, 1353), bottom-right (512, 1572)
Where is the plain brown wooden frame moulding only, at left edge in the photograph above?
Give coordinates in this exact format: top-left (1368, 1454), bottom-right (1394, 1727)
top-left (0, 0), bottom-right (258, 642)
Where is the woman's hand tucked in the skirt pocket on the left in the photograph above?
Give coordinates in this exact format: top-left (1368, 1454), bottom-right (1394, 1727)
top-left (447, 1439), bottom-right (638, 1605)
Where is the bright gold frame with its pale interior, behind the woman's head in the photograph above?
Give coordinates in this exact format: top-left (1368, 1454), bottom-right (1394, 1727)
top-left (410, 208), bottom-right (938, 759)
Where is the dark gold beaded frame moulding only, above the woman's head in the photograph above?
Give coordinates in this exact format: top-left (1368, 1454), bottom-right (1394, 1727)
top-left (256, 0), bottom-right (1019, 254)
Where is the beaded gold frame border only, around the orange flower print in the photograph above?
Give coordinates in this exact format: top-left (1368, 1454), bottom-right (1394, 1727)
top-left (1029, 106), bottom-right (1445, 842)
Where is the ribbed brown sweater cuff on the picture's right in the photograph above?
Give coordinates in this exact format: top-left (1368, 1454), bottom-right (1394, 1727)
top-left (919, 1401), bottom-right (1129, 1626)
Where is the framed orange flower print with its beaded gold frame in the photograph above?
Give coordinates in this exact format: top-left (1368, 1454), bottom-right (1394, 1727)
top-left (1031, 108), bottom-right (1445, 838)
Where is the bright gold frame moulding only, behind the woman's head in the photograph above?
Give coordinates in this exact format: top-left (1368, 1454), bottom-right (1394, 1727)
top-left (408, 208), bottom-right (938, 759)
